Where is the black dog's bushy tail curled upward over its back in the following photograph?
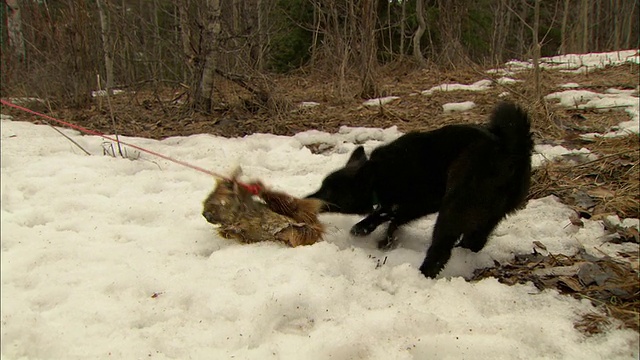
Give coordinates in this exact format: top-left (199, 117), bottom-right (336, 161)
top-left (489, 102), bottom-right (533, 156)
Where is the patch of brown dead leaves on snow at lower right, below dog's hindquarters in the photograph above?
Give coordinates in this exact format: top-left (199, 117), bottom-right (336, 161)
top-left (472, 244), bottom-right (640, 334)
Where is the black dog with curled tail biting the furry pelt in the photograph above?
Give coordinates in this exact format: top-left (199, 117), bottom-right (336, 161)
top-left (307, 103), bottom-right (533, 277)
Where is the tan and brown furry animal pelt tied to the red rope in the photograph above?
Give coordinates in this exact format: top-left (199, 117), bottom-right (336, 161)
top-left (202, 174), bottom-right (324, 247)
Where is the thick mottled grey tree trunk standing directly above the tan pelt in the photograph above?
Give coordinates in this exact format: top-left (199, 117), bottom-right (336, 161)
top-left (194, 0), bottom-right (221, 113)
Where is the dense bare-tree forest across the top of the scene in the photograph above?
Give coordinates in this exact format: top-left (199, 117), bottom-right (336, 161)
top-left (0, 0), bottom-right (639, 124)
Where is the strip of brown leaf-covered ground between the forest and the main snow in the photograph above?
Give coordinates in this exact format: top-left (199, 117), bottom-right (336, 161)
top-left (3, 65), bottom-right (638, 141)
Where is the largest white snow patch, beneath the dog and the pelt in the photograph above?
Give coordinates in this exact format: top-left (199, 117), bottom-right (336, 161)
top-left (0, 117), bottom-right (639, 359)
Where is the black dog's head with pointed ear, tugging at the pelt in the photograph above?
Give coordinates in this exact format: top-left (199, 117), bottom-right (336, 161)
top-left (307, 146), bottom-right (373, 214)
